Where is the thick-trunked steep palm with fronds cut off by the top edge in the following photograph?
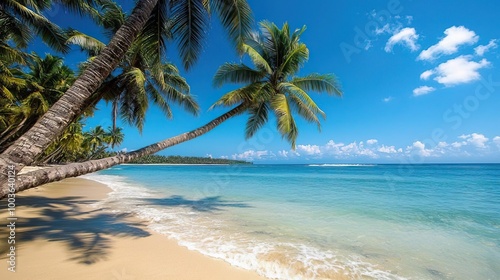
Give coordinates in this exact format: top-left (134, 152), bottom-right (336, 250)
top-left (0, 0), bottom-right (251, 177)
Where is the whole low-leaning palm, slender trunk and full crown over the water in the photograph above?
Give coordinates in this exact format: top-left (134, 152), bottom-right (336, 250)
top-left (0, 22), bottom-right (341, 197)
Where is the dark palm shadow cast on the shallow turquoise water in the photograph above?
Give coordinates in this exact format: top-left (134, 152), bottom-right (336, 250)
top-left (143, 195), bottom-right (252, 212)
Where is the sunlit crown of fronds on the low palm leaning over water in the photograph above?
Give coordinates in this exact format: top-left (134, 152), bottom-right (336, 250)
top-left (212, 21), bottom-right (342, 149)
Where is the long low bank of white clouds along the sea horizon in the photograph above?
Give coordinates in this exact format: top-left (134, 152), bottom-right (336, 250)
top-left (227, 132), bottom-right (500, 162)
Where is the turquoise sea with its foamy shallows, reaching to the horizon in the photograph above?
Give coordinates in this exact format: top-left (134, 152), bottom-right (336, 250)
top-left (86, 164), bottom-right (500, 279)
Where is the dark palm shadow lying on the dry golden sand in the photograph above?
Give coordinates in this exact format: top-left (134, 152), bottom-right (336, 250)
top-left (0, 196), bottom-right (150, 265)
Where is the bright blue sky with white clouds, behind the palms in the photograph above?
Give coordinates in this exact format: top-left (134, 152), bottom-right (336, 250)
top-left (37, 0), bottom-right (500, 163)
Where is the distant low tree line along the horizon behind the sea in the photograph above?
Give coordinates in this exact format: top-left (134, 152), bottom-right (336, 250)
top-left (130, 155), bottom-right (252, 164)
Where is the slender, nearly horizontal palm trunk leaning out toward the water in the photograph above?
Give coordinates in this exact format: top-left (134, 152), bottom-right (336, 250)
top-left (0, 104), bottom-right (247, 199)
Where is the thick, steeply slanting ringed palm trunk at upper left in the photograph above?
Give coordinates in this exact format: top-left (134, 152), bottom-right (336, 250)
top-left (0, 0), bottom-right (158, 182)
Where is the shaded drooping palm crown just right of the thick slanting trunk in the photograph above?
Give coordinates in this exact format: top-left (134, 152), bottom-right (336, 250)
top-left (86, 4), bottom-right (199, 131)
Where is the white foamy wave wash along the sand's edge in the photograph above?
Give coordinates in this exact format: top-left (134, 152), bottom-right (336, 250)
top-left (84, 174), bottom-right (404, 280)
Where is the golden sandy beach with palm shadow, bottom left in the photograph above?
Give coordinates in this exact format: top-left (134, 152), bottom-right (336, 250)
top-left (0, 178), bottom-right (265, 280)
